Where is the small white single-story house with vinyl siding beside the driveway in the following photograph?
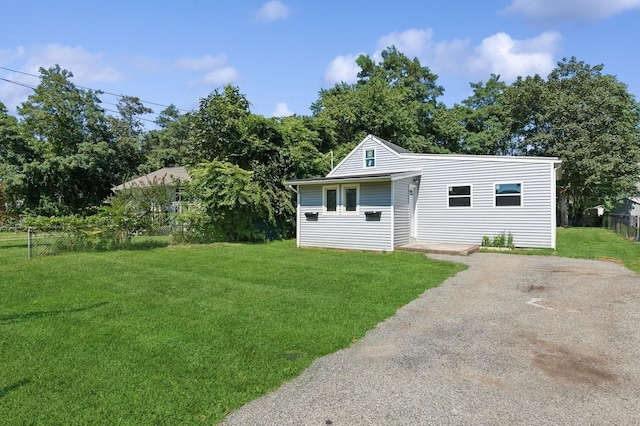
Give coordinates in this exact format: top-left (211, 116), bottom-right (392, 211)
top-left (286, 135), bottom-right (561, 251)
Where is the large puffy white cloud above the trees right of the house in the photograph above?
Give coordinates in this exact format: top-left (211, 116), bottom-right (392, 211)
top-left (466, 31), bottom-right (561, 82)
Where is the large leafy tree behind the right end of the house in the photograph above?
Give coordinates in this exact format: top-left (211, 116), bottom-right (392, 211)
top-left (510, 58), bottom-right (640, 222)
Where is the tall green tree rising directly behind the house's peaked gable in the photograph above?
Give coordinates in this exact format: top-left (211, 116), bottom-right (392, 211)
top-left (311, 46), bottom-right (444, 152)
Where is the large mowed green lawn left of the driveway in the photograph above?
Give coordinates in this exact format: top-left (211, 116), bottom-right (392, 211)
top-left (0, 238), bottom-right (464, 425)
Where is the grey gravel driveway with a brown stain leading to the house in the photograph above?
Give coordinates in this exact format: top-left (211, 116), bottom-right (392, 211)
top-left (225, 253), bottom-right (640, 425)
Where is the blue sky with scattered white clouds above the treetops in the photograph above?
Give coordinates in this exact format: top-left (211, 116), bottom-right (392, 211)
top-left (0, 0), bottom-right (640, 121)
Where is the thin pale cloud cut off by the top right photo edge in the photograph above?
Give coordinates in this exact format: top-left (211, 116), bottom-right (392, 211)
top-left (503, 0), bottom-right (640, 25)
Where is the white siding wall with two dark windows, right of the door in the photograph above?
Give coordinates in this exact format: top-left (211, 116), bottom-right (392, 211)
top-left (417, 157), bottom-right (555, 247)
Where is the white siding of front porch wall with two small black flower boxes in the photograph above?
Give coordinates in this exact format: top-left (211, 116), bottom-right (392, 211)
top-left (298, 182), bottom-right (393, 251)
